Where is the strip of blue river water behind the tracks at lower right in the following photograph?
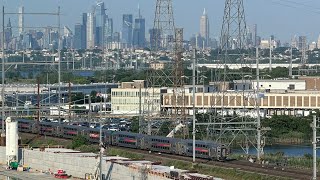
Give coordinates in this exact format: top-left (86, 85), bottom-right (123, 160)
top-left (232, 145), bottom-right (320, 156)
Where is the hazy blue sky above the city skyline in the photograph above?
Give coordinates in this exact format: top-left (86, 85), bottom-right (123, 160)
top-left (0, 0), bottom-right (320, 41)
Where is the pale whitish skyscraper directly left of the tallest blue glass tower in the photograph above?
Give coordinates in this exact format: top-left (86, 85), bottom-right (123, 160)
top-left (87, 13), bottom-right (96, 49)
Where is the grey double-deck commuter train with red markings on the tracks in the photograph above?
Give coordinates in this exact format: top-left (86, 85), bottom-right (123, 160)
top-left (13, 120), bottom-right (230, 161)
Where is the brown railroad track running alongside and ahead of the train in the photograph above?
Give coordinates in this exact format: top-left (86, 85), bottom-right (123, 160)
top-left (22, 133), bottom-right (312, 180)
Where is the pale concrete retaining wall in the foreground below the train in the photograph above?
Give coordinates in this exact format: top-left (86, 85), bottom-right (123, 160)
top-left (0, 147), bottom-right (168, 180)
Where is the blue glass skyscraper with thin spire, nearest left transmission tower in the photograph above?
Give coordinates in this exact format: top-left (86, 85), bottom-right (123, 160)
top-left (133, 7), bottom-right (146, 48)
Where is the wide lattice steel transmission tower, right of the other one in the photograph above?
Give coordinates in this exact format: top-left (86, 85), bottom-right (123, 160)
top-left (197, 0), bottom-right (261, 160)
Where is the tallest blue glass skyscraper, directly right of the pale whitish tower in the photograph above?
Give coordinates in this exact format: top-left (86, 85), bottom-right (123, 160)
top-left (95, 2), bottom-right (107, 47)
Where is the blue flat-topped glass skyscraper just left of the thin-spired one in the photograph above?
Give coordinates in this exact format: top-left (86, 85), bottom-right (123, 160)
top-left (121, 14), bottom-right (132, 47)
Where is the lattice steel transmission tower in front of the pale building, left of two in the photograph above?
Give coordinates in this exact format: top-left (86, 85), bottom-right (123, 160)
top-left (144, 0), bottom-right (185, 138)
